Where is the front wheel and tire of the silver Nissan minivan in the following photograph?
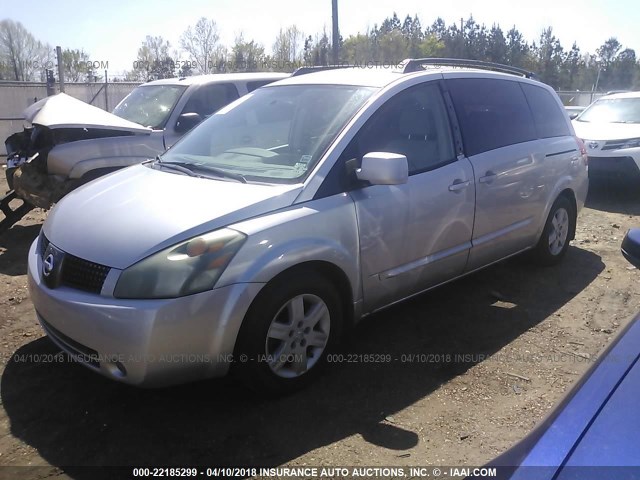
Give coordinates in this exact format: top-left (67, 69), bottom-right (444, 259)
top-left (233, 271), bottom-right (343, 395)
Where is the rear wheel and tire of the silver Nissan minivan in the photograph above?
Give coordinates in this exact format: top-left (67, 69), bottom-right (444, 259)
top-left (533, 197), bottom-right (576, 266)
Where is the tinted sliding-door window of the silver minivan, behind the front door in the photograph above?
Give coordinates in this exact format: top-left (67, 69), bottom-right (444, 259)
top-left (447, 78), bottom-right (538, 156)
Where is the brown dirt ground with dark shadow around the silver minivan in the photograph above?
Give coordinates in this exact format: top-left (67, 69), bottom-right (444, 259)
top-left (0, 171), bottom-right (640, 478)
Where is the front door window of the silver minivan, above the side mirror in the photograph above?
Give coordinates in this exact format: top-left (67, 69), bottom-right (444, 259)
top-left (355, 82), bottom-right (455, 175)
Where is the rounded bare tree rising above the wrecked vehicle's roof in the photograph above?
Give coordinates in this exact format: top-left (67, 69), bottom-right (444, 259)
top-left (180, 17), bottom-right (221, 73)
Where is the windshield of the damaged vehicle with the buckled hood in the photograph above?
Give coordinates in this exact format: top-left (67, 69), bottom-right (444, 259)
top-left (113, 85), bottom-right (187, 130)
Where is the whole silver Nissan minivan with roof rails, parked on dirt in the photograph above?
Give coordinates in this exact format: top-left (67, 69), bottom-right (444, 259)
top-left (29, 60), bottom-right (588, 392)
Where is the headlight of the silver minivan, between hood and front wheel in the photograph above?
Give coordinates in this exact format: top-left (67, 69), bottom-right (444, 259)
top-left (113, 228), bottom-right (246, 298)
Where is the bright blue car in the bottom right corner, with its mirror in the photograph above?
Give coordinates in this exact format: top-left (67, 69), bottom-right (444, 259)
top-left (491, 229), bottom-right (640, 480)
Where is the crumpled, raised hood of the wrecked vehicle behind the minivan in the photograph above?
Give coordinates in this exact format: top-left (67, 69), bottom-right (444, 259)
top-left (23, 93), bottom-right (152, 134)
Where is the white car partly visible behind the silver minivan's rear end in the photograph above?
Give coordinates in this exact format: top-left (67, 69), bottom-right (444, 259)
top-left (573, 92), bottom-right (640, 183)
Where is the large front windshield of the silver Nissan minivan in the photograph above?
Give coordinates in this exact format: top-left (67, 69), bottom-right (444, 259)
top-left (161, 85), bottom-right (377, 183)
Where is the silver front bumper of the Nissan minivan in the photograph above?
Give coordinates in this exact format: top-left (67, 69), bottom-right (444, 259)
top-left (28, 239), bottom-right (263, 387)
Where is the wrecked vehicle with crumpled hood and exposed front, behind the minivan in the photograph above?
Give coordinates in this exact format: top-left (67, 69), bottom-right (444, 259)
top-left (6, 73), bottom-right (288, 208)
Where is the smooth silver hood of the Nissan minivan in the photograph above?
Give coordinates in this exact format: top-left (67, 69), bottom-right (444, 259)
top-left (43, 165), bottom-right (302, 269)
